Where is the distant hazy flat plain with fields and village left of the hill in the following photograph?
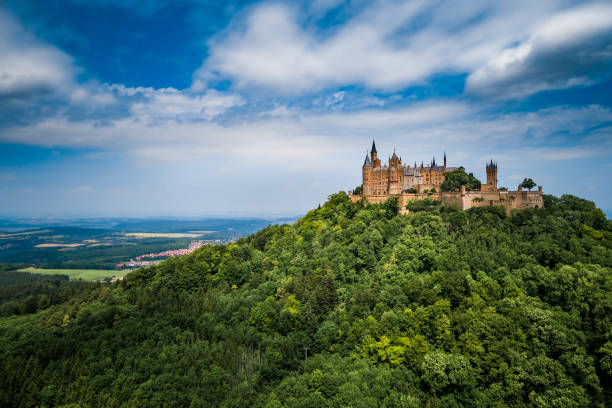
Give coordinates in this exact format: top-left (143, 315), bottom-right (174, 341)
top-left (0, 218), bottom-right (296, 270)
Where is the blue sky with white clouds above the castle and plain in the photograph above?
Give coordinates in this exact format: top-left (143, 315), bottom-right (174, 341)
top-left (0, 0), bottom-right (612, 217)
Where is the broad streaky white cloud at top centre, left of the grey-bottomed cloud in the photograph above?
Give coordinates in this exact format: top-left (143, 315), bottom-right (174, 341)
top-left (194, 0), bottom-right (596, 94)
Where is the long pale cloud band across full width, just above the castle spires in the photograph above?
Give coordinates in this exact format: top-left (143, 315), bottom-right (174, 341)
top-left (0, 102), bottom-right (612, 170)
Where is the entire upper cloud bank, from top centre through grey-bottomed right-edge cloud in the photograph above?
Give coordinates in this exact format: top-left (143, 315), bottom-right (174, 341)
top-left (194, 1), bottom-right (612, 96)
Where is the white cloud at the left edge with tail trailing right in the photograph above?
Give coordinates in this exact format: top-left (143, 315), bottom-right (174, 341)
top-left (0, 11), bottom-right (245, 127)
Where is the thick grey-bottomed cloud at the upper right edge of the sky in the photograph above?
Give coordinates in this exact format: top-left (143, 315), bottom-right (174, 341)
top-left (466, 4), bottom-right (612, 98)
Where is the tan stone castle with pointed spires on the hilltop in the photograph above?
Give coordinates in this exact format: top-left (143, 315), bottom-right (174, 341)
top-left (349, 142), bottom-right (543, 214)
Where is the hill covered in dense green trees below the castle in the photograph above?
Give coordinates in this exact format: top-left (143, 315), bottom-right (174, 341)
top-left (0, 193), bottom-right (612, 407)
